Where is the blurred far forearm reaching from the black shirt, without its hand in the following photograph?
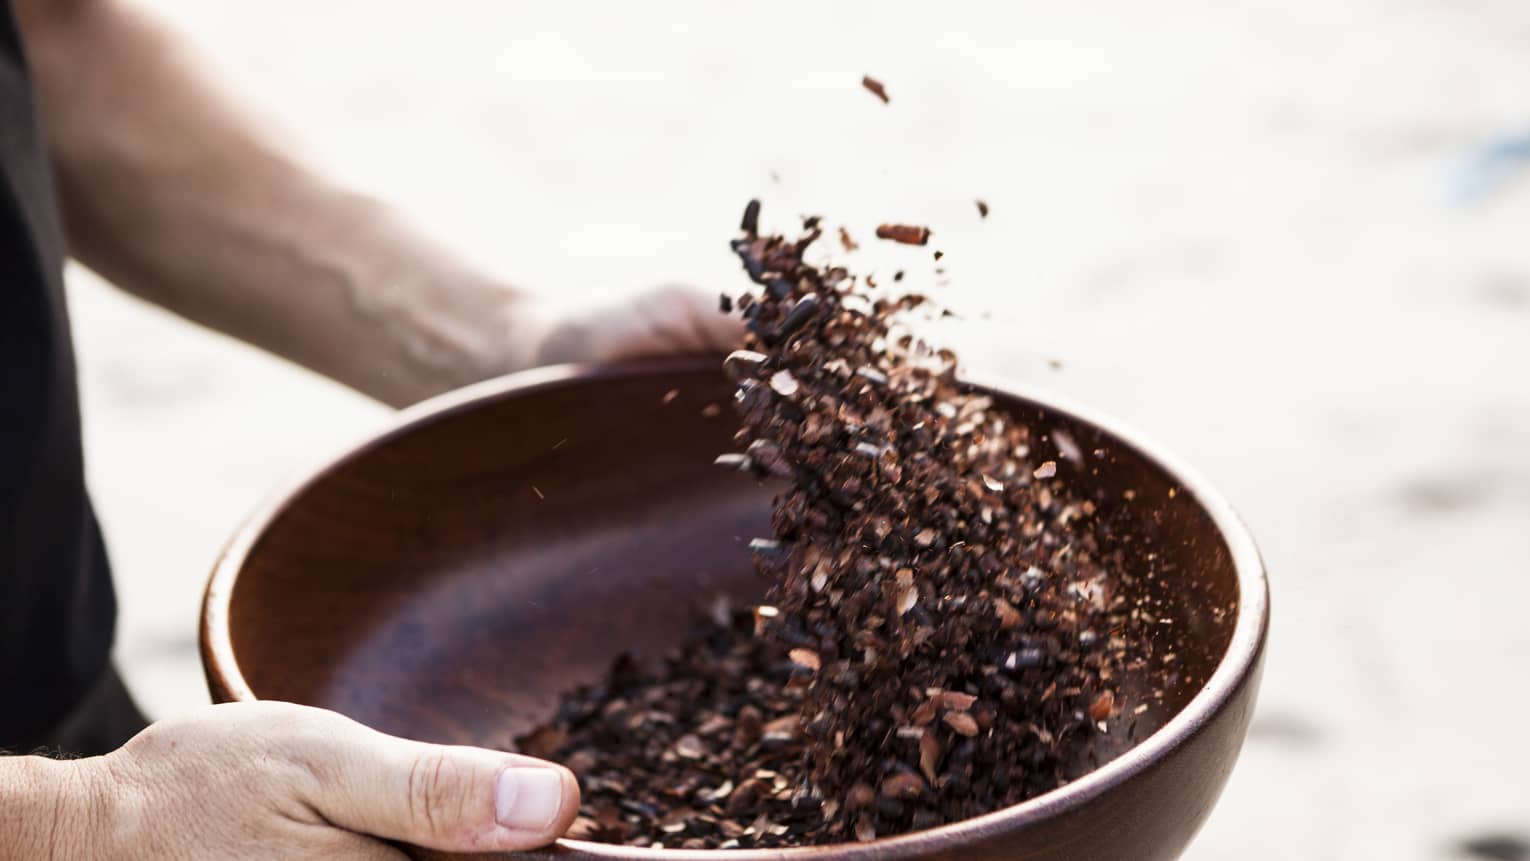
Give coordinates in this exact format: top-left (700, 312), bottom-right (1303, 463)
top-left (21, 0), bottom-right (517, 404)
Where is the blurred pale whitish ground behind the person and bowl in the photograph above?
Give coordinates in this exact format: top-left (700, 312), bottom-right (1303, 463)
top-left (72, 0), bottom-right (1530, 861)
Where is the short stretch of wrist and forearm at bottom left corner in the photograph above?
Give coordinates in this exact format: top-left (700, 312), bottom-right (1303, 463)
top-left (0, 755), bottom-right (107, 858)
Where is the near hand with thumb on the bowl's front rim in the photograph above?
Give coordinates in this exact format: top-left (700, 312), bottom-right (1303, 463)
top-left (67, 702), bottom-right (578, 861)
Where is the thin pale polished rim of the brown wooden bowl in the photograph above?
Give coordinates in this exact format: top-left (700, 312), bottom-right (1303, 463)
top-left (199, 355), bottom-right (1270, 861)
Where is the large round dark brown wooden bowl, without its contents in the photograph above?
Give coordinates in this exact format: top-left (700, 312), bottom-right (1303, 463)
top-left (202, 358), bottom-right (1268, 861)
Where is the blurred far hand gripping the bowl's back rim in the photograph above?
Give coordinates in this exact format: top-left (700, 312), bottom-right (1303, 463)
top-left (506, 284), bottom-right (744, 370)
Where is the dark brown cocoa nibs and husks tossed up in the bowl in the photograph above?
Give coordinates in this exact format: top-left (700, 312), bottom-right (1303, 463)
top-left (522, 202), bottom-right (1143, 849)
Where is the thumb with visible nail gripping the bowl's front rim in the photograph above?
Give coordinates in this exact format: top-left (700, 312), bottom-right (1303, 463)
top-left (296, 720), bottom-right (578, 852)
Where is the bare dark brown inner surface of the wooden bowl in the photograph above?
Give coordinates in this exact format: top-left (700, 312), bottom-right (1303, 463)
top-left (208, 361), bottom-right (1238, 783)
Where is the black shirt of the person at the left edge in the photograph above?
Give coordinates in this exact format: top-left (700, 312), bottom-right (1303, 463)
top-left (0, 0), bottom-right (116, 749)
